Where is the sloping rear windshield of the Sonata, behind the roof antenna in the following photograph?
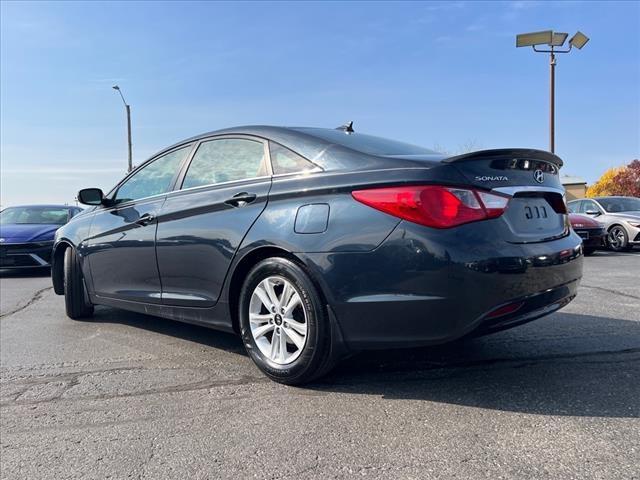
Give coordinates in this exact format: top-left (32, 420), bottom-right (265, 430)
top-left (297, 128), bottom-right (437, 156)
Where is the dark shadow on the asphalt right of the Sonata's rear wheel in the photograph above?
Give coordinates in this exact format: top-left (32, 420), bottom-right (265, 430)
top-left (312, 313), bottom-right (640, 418)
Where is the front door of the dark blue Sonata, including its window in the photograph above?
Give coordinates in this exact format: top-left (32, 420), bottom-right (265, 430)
top-left (86, 146), bottom-right (191, 303)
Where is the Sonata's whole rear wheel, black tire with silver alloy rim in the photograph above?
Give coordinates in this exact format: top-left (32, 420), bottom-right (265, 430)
top-left (239, 257), bottom-right (331, 385)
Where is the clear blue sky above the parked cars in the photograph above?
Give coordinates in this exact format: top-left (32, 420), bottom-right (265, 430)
top-left (0, 1), bottom-right (640, 206)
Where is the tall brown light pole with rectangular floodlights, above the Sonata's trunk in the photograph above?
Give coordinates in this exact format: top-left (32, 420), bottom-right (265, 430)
top-left (516, 30), bottom-right (589, 153)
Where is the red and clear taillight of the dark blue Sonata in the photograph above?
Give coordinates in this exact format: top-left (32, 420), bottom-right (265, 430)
top-left (351, 185), bottom-right (509, 228)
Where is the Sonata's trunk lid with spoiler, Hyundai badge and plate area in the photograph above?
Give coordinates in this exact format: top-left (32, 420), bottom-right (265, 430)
top-left (444, 149), bottom-right (569, 243)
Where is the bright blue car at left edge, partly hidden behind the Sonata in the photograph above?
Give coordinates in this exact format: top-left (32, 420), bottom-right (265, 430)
top-left (0, 205), bottom-right (82, 269)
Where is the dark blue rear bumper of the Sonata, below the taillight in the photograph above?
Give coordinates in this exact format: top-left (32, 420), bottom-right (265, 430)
top-left (305, 221), bottom-right (583, 349)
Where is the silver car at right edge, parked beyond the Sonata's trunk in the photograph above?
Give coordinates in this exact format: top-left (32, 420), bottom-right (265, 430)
top-left (567, 197), bottom-right (640, 251)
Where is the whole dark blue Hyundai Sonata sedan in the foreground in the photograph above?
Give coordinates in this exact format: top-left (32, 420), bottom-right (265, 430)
top-left (52, 126), bottom-right (583, 384)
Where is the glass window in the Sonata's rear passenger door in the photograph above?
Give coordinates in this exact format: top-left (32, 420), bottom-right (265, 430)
top-left (182, 138), bottom-right (268, 189)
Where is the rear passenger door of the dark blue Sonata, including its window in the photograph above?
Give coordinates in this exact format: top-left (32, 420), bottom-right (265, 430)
top-left (156, 136), bottom-right (271, 307)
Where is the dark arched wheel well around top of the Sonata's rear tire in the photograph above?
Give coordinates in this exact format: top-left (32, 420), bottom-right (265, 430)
top-left (229, 247), bottom-right (326, 334)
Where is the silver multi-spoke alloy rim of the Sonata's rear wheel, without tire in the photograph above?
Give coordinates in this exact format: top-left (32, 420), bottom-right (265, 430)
top-left (249, 276), bottom-right (308, 365)
